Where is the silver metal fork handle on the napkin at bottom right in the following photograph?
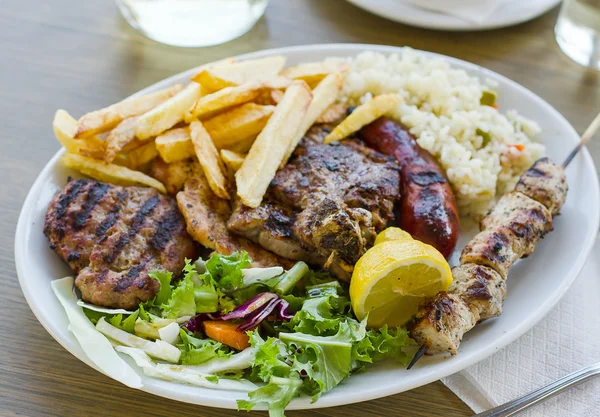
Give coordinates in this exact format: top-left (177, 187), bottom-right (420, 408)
top-left (473, 362), bottom-right (600, 417)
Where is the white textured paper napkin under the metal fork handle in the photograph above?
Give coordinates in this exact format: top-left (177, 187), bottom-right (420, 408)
top-left (442, 239), bottom-right (600, 417)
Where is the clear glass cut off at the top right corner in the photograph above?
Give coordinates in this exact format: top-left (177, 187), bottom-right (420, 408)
top-left (554, 0), bottom-right (600, 70)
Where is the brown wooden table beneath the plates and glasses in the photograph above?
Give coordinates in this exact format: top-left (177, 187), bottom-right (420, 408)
top-left (0, 0), bottom-right (600, 417)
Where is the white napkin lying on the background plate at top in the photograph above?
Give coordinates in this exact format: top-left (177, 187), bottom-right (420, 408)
top-left (403, 0), bottom-right (520, 24)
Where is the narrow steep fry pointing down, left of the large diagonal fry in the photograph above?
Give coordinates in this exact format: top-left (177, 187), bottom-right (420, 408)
top-left (190, 121), bottom-right (229, 199)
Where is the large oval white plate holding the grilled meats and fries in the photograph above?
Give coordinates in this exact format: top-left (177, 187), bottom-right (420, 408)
top-left (15, 44), bottom-right (600, 409)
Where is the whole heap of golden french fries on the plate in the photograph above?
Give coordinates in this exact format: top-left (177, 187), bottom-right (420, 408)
top-left (53, 56), bottom-right (354, 213)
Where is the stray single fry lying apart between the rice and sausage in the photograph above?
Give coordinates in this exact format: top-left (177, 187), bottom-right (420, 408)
top-left (323, 94), bottom-right (402, 143)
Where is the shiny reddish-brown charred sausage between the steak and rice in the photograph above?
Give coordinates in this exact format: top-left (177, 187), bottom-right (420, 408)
top-left (359, 117), bottom-right (460, 257)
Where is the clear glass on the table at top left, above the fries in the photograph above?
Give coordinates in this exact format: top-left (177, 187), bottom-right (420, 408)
top-left (116, 0), bottom-right (269, 47)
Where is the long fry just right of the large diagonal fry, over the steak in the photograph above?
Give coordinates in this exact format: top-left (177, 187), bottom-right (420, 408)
top-left (279, 73), bottom-right (343, 168)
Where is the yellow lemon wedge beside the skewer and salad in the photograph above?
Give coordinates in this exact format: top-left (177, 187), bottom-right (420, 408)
top-left (350, 227), bottom-right (452, 328)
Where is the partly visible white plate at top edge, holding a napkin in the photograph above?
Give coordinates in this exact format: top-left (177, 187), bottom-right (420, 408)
top-left (348, 0), bottom-right (560, 31)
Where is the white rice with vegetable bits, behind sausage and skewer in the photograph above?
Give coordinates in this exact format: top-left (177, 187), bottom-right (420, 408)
top-left (342, 48), bottom-right (545, 218)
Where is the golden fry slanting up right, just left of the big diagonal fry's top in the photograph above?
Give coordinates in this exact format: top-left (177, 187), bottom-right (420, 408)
top-left (186, 82), bottom-right (265, 122)
